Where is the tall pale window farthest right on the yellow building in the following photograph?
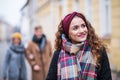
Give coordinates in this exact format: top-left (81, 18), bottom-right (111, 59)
top-left (100, 0), bottom-right (111, 38)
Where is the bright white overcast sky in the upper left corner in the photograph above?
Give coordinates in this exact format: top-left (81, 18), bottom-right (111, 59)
top-left (0, 0), bottom-right (26, 25)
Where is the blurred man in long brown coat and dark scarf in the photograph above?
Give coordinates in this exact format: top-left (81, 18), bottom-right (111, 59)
top-left (26, 26), bottom-right (52, 80)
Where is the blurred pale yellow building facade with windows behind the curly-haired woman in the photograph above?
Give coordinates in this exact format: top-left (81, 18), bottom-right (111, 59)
top-left (21, 0), bottom-right (120, 70)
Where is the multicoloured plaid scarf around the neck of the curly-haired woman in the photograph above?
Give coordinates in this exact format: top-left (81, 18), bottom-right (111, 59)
top-left (58, 34), bottom-right (97, 80)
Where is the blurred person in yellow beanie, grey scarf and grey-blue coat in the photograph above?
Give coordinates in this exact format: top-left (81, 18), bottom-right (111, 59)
top-left (3, 32), bottom-right (27, 80)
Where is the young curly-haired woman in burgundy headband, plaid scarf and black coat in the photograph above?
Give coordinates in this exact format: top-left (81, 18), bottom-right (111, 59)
top-left (46, 12), bottom-right (112, 80)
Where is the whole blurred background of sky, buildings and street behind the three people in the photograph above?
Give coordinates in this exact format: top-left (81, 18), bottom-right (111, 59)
top-left (0, 0), bottom-right (120, 80)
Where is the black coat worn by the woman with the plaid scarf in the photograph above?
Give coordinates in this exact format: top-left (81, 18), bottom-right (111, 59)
top-left (46, 48), bottom-right (112, 80)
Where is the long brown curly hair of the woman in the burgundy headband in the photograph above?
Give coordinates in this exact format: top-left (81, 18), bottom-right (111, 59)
top-left (55, 13), bottom-right (104, 66)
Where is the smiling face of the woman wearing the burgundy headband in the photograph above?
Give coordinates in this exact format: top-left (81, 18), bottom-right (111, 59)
top-left (69, 16), bottom-right (88, 44)
